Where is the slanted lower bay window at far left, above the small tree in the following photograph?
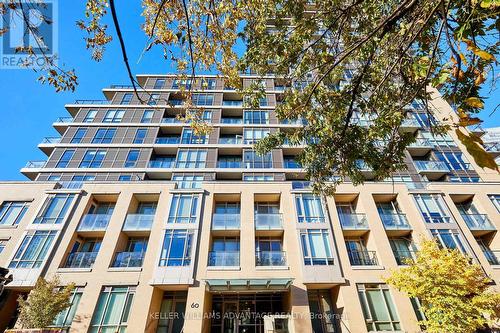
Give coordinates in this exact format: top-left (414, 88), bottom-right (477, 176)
top-left (9, 230), bottom-right (57, 268)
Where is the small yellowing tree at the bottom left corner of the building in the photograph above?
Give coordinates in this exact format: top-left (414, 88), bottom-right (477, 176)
top-left (17, 277), bottom-right (75, 328)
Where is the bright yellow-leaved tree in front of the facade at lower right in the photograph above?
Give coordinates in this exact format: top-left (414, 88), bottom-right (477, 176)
top-left (386, 240), bottom-right (500, 333)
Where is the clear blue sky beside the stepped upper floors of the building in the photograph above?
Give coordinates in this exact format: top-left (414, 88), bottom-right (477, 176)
top-left (0, 0), bottom-right (500, 180)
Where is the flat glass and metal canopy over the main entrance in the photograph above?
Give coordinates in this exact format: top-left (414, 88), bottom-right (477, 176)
top-left (205, 279), bottom-right (292, 291)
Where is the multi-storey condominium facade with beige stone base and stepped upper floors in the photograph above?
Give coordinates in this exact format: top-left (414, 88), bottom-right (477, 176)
top-left (0, 75), bottom-right (500, 333)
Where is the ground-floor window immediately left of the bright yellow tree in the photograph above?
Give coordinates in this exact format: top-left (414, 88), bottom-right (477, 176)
top-left (358, 284), bottom-right (401, 332)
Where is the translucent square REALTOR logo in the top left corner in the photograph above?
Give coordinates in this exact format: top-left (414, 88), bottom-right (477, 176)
top-left (0, 0), bottom-right (58, 69)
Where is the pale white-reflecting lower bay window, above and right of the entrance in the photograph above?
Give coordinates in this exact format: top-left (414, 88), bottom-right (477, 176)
top-left (300, 229), bottom-right (333, 266)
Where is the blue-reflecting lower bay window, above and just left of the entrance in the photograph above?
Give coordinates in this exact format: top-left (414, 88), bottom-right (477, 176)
top-left (159, 229), bottom-right (193, 266)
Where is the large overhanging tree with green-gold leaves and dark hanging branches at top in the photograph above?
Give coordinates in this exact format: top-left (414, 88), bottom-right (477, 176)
top-left (1, 0), bottom-right (500, 193)
